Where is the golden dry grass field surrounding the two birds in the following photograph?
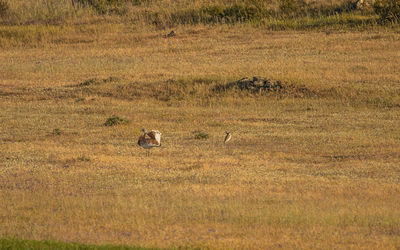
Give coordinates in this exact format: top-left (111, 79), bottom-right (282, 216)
top-left (0, 8), bottom-right (400, 249)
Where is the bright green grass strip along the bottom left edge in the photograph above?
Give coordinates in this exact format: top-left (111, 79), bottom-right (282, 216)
top-left (0, 239), bottom-right (158, 250)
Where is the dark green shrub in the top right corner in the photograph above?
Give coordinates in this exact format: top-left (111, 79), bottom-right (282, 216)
top-left (374, 0), bottom-right (400, 23)
